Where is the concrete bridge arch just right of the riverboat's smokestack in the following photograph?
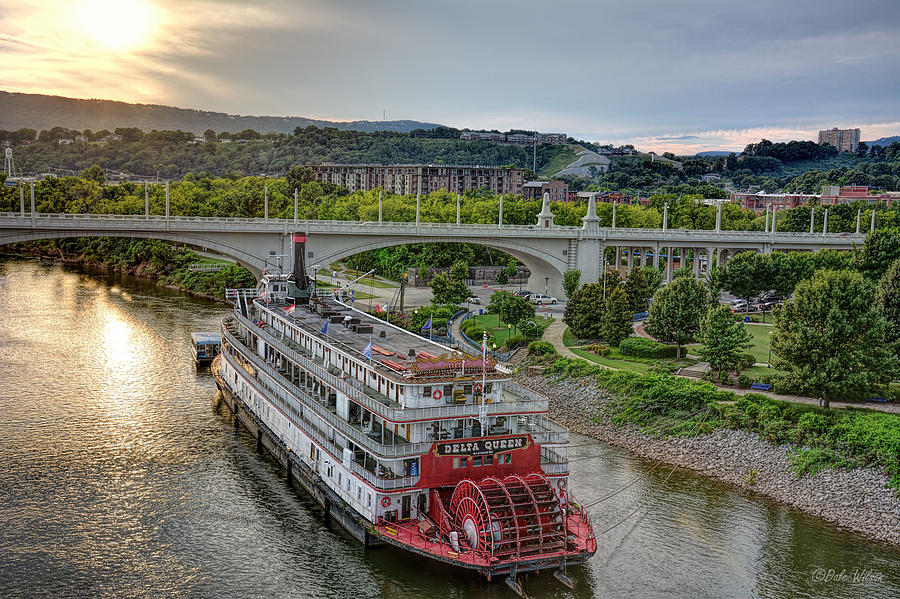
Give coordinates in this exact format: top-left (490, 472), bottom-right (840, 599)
top-left (308, 233), bottom-right (568, 297)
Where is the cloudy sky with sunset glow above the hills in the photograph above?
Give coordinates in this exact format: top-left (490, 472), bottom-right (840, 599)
top-left (0, 0), bottom-right (900, 154)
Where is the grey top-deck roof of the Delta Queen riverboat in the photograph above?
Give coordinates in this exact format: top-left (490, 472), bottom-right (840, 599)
top-left (256, 297), bottom-right (508, 380)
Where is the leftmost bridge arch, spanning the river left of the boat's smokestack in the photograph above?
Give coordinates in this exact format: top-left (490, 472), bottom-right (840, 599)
top-left (0, 229), bottom-right (266, 278)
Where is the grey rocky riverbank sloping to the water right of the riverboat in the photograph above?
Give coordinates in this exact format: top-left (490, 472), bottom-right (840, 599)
top-left (518, 376), bottom-right (900, 545)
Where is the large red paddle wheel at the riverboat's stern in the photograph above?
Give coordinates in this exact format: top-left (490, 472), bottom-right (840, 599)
top-left (449, 474), bottom-right (566, 560)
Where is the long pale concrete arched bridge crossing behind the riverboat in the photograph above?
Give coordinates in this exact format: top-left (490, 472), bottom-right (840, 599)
top-left (0, 197), bottom-right (865, 298)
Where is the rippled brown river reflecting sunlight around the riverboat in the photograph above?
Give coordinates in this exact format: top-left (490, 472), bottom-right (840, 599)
top-left (0, 257), bottom-right (900, 599)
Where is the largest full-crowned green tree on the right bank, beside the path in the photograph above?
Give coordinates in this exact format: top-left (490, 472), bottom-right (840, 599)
top-left (771, 270), bottom-right (897, 408)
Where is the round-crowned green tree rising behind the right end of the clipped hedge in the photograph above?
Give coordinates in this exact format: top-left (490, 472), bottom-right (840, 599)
top-left (647, 277), bottom-right (710, 357)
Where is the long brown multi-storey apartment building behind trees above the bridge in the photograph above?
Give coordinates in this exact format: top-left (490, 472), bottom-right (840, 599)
top-left (309, 164), bottom-right (524, 195)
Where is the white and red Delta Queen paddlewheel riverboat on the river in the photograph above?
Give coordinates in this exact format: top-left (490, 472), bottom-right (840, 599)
top-left (213, 234), bottom-right (597, 593)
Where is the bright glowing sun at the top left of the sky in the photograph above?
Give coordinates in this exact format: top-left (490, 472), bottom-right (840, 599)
top-left (75, 0), bottom-right (159, 52)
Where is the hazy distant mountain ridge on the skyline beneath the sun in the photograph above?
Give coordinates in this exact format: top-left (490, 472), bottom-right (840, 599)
top-left (0, 91), bottom-right (439, 134)
